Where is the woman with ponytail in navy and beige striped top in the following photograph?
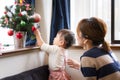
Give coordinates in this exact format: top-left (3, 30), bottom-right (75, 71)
top-left (67, 17), bottom-right (120, 80)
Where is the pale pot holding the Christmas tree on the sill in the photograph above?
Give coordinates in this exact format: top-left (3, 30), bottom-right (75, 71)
top-left (14, 31), bottom-right (27, 49)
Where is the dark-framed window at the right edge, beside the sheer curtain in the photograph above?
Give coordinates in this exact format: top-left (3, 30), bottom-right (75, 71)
top-left (111, 0), bottom-right (120, 44)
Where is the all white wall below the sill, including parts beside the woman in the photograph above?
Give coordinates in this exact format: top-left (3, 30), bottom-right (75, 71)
top-left (0, 48), bottom-right (120, 80)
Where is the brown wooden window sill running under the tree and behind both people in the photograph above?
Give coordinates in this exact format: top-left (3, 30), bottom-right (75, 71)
top-left (0, 44), bottom-right (120, 58)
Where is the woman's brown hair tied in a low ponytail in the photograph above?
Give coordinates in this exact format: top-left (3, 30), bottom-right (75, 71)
top-left (77, 17), bottom-right (111, 52)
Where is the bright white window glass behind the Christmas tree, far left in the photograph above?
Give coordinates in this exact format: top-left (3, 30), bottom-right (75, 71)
top-left (0, 0), bottom-right (14, 45)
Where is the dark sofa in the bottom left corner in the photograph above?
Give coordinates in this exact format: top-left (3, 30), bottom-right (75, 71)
top-left (0, 65), bottom-right (49, 80)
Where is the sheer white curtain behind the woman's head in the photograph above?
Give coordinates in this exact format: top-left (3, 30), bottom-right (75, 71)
top-left (71, 0), bottom-right (111, 42)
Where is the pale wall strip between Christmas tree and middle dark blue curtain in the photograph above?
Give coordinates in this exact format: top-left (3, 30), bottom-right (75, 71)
top-left (35, 0), bottom-right (52, 43)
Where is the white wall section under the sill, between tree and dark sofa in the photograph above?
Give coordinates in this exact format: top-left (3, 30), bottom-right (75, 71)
top-left (0, 50), bottom-right (47, 79)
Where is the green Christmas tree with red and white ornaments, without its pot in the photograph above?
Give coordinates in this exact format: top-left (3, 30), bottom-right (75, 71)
top-left (0, 0), bottom-right (41, 38)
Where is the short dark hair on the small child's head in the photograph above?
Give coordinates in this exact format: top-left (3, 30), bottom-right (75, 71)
top-left (58, 29), bottom-right (75, 49)
